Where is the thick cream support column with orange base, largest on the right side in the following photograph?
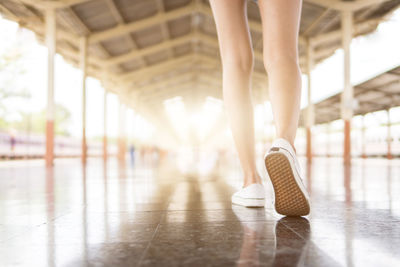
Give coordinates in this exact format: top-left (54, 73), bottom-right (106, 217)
top-left (341, 10), bottom-right (353, 164)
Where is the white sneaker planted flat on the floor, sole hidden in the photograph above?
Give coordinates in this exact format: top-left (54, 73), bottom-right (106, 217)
top-left (232, 184), bottom-right (265, 207)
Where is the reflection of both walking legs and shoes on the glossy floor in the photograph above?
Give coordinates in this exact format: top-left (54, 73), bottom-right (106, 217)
top-left (232, 206), bottom-right (310, 266)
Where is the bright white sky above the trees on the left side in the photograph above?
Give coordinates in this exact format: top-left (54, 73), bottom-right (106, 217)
top-left (0, 19), bottom-right (118, 137)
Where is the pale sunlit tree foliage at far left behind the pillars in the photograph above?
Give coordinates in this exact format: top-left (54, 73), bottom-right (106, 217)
top-left (0, 25), bottom-right (71, 135)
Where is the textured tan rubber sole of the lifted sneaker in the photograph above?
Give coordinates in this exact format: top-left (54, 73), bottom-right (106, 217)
top-left (265, 152), bottom-right (310, 216)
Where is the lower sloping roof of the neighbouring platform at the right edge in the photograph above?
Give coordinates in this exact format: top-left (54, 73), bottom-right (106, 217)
top-left (300, 66), bottom-right (400, 124)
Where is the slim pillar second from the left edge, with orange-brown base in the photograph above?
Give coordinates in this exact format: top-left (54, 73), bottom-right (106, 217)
top-left (80, 37), bottom-right (88, 164)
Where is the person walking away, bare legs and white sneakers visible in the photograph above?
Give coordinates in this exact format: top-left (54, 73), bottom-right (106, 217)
top-left (210, 0), bottom-right (310, 216)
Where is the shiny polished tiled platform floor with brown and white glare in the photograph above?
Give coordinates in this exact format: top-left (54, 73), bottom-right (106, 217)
top-left (0, 158), bottom-right (400, 266)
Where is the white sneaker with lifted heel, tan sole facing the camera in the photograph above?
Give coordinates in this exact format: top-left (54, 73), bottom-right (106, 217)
top-left (265, 138), bottom-right (310, 216)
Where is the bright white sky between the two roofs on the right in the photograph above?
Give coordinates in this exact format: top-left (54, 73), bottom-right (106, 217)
top-left (302, 9), bottom-right (400, 107)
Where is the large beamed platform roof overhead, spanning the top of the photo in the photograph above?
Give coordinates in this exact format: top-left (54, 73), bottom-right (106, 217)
top-left (0, 0), bottom-right (400, 120)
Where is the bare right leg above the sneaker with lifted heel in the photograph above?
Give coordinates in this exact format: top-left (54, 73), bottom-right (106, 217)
top-left (259, 0), bottom-right (301, 150)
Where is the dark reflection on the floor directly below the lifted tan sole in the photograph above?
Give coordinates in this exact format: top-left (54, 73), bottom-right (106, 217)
top-left (273, 217), bottom-right (310, 266)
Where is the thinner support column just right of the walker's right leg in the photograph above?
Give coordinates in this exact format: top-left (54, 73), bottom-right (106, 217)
top-left (306, 41), bottom-right (315, 163)
